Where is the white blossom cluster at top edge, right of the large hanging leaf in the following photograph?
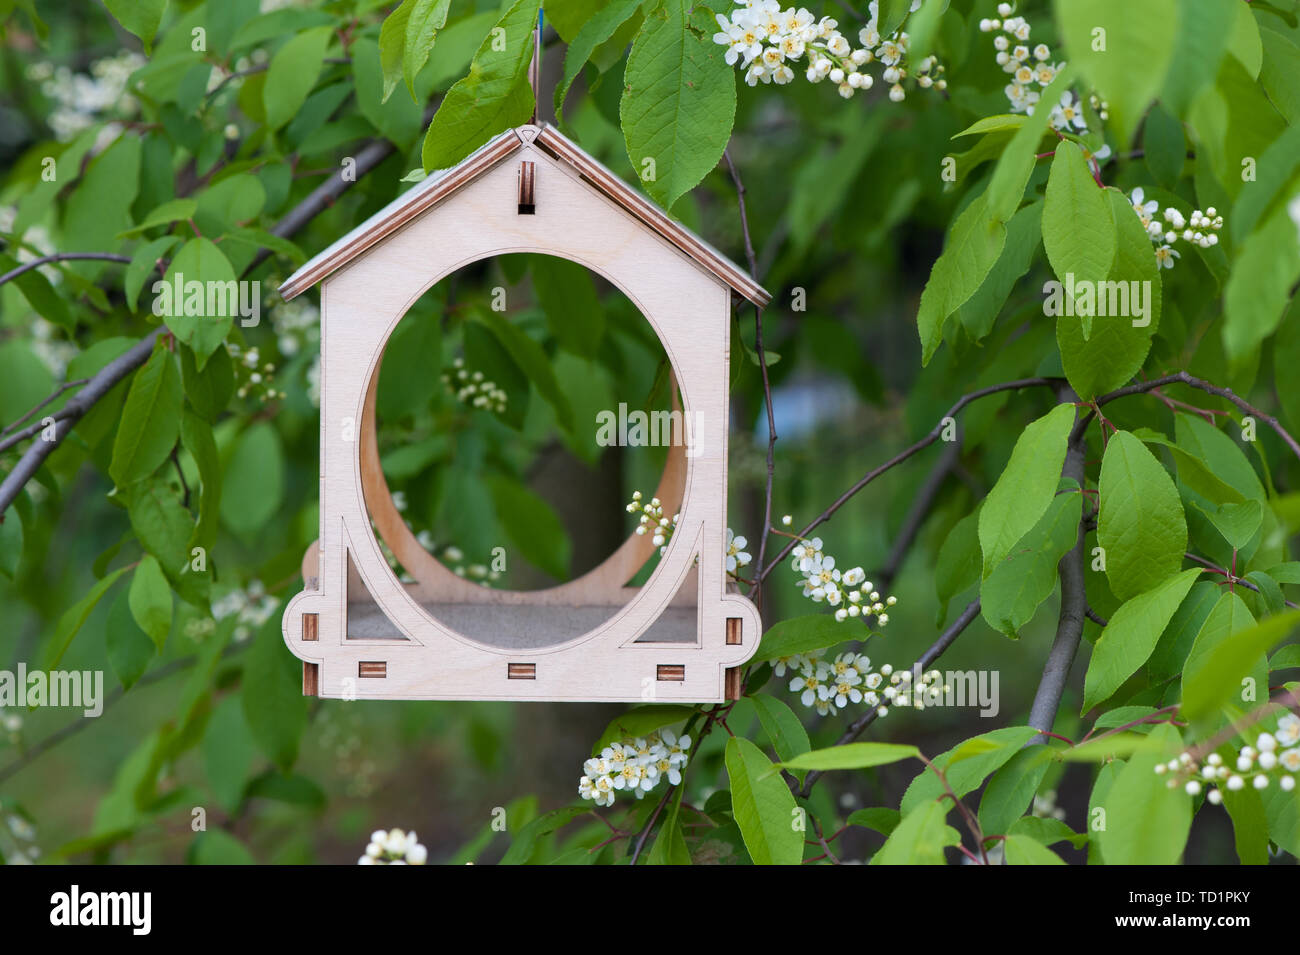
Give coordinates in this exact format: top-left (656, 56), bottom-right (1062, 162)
top-left (714, 0), bottom-right (948, 103)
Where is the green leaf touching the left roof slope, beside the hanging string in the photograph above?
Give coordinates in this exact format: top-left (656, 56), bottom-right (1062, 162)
top-left (423, 0), bottom-right (540, 172)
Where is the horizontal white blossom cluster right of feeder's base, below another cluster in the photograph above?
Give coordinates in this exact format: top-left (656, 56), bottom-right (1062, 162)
top-left (772, 650), bottom-right (946, 716)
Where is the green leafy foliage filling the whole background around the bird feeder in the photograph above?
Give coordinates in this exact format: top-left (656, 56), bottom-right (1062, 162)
top-left (0, 0), bottom-right (1300, 863)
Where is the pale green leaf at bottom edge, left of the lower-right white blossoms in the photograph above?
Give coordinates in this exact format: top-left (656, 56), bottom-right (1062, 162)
top-left (1088, 724), bottom-right (1192, 865)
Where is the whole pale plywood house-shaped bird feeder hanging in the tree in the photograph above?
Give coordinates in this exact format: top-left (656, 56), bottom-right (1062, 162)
top-left (281, 125), bottom-right (770, 703)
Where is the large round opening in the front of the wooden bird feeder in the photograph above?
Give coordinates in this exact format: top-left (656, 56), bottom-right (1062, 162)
top-left (350, 253), bottom-right (694, 647)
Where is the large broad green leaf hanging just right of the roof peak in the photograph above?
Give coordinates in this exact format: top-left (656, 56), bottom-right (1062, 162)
top-left (619, 0), bottom-right (736, 209)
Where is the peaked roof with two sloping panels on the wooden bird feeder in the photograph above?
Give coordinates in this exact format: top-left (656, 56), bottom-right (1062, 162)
top-left (271, 123), bottom-right (772, 308)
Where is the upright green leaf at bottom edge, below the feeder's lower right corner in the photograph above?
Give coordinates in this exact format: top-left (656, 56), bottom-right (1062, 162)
top-left (725, 737), bottom-right (803, 865)
